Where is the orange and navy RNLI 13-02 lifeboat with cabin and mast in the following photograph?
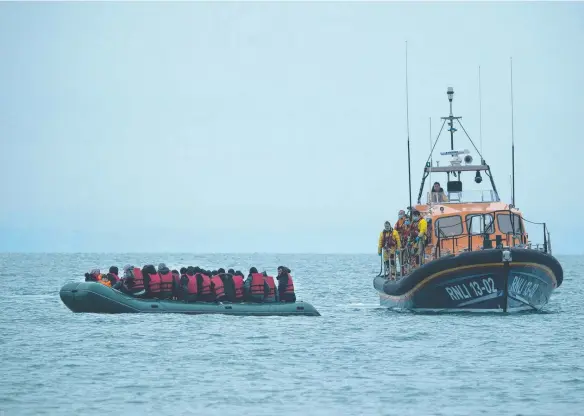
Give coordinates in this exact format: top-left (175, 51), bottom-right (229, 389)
top-left (373, 88), bottom-right (563, 313)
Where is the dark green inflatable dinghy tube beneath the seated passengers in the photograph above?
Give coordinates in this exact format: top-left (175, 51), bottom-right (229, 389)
top-left (59, 282), bottom-right (320, 316)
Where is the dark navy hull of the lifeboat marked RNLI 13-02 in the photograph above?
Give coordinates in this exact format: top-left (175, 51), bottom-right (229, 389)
top-left (373, 248), bottom-right (563, 313)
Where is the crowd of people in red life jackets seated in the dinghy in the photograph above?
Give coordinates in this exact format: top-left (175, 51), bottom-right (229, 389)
top-left (85, 263), bottom-right (296, 303)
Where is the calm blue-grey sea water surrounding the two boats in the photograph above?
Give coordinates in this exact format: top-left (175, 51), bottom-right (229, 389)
top-left (0, 254), bottom-right (584, 416)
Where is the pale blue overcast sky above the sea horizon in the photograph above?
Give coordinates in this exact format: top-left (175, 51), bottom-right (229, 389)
top-left (0, 2), bottom-right (584, 254)
